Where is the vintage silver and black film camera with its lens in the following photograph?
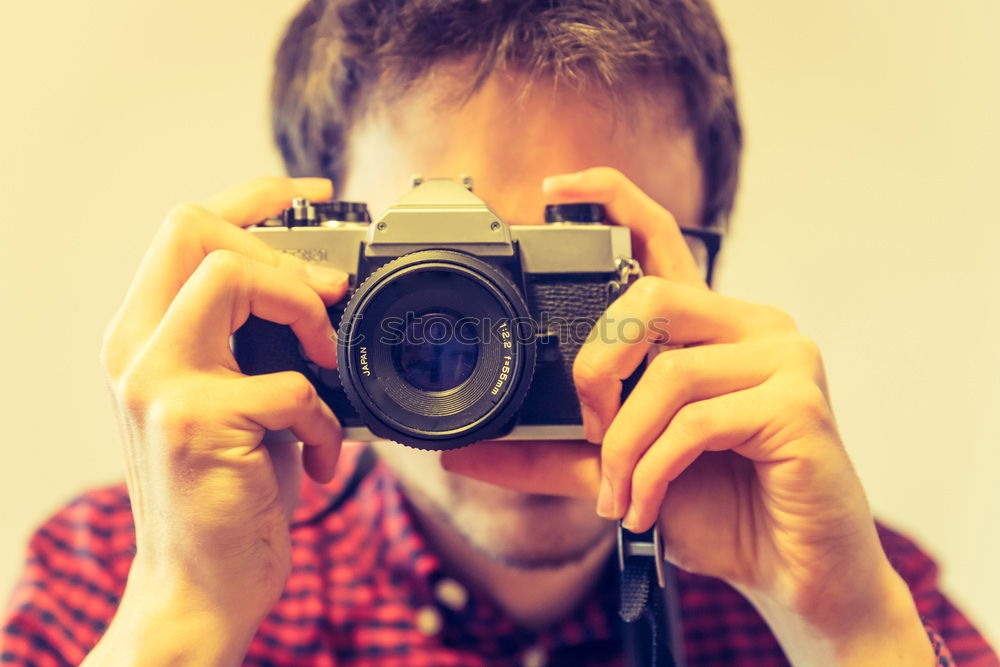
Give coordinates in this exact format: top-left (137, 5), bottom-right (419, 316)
top-left (232, 180), bottom-right (640, 450)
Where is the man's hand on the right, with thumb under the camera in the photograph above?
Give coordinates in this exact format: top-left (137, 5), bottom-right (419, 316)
top-left (443, 168), bottom-right (933, 665)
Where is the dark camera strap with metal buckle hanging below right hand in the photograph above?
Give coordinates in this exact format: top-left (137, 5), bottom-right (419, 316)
top-left (618, 522), bottom-right (684, 667)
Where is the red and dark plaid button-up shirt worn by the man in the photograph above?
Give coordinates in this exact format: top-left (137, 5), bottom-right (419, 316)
top-left (0, 448), bottom-right (1000, 667)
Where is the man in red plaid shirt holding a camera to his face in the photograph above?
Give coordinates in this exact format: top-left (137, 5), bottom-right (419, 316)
top-left (2, 0), bottom-right (996, 665)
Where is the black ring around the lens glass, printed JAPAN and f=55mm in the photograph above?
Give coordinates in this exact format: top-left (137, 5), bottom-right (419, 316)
top-left (338, 250), bottom-right (535, 449)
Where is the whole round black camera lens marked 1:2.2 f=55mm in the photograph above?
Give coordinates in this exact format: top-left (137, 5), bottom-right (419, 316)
top-left (338, 250), bottom-right (535, 449)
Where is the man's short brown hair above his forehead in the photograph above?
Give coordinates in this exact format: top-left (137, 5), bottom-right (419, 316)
top-left (272, 0), bottom-right (742, 223)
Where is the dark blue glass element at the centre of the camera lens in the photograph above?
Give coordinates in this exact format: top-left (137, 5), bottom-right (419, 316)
top-left (395, 312), bottom-right (479, 392)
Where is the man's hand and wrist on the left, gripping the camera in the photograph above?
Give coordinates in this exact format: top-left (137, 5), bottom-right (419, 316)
top-left (89, 178), bottom-right (347, 664)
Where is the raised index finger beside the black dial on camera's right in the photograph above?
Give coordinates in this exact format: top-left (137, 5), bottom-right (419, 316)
top-left (542, 167), bottom-right (707, 288)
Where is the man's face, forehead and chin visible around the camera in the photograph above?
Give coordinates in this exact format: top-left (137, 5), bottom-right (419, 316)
top-left (338, 67), bottom-right (702, 567)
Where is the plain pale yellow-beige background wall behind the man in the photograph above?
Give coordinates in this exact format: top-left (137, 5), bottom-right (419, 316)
top-left (0, 0), bottom-right (1000, 643)
